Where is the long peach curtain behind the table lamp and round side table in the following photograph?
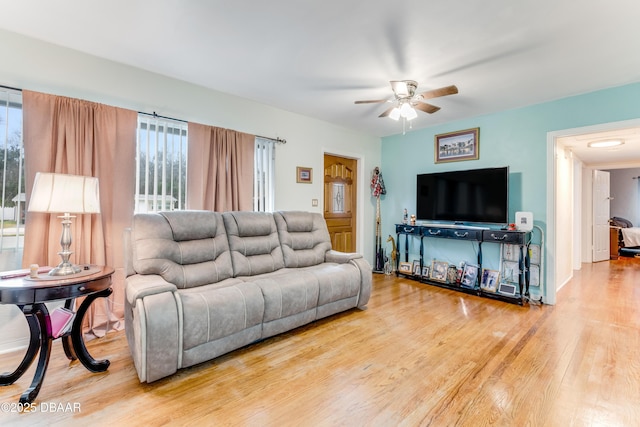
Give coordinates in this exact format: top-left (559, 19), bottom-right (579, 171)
top-left (22, 90), bottom-right (137, 338)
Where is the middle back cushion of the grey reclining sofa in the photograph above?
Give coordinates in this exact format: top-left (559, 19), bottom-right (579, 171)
top-left (222, 211), bottom-right (284, 277)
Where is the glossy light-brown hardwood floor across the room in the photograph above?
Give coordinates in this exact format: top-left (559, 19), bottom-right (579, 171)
top-left (0, 258), bottom-right (640, 426)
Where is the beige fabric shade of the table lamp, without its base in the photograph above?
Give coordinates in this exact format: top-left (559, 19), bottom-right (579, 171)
top-left (29, 172), bottom-right (100, 214)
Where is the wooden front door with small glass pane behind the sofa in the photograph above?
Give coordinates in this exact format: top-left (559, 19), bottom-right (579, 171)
top-left (324, 154), bottom-right (357, 252)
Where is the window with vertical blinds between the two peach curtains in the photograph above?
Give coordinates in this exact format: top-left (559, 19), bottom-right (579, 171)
top-left (135, 114), bottom-right (187, 213)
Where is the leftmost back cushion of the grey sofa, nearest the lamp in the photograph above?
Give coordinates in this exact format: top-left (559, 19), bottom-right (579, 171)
top-left (131, 211), bottom-right (233, 289)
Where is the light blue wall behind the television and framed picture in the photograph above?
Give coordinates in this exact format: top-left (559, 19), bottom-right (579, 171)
top-left (381, 83), bottom-right (640, 298)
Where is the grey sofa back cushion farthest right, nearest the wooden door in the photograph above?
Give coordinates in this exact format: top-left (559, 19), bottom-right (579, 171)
top-left (273, 211), bottom-right (331, 267)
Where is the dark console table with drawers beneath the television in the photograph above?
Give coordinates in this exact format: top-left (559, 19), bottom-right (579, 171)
top-left (396, 224), bottom-right (531, 305)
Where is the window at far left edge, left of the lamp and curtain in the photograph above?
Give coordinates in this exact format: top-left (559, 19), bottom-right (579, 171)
top-left (0, 88), bottom-right (26, 270)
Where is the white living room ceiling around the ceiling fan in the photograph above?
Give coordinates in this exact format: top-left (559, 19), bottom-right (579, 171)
top-left (0, 0), bottom-right (640, 164)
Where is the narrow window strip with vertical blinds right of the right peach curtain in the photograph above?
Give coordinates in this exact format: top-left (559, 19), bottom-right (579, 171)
top-left (253, 136), bottom-right (276, 212)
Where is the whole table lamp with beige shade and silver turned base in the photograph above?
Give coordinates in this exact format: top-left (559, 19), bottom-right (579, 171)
top-left (29, 172), bottom-right (100, 276)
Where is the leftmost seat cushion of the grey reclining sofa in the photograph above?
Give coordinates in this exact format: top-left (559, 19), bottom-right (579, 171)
top-left (178, 279), bottom-right (265, 350)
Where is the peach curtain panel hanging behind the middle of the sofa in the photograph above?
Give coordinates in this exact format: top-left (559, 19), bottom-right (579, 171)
top-left (187, 123), bottom-right (255, 212)
